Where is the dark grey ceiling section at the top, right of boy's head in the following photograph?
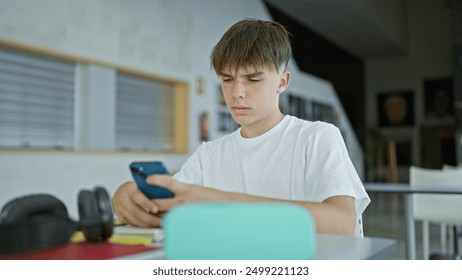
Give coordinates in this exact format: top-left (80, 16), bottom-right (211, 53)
top-left (264, 0), bottom-right (406, 59)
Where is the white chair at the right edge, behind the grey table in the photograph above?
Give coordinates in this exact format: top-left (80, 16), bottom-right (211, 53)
top-left (410, 166), bottom-right (462, 259)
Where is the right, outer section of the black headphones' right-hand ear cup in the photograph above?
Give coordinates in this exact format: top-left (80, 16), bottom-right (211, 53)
top-left (93, 187), bottom-right (114, 240)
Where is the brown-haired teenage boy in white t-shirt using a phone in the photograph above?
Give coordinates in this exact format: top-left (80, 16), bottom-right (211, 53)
top-left (112, 19), bottom-right (370, 236)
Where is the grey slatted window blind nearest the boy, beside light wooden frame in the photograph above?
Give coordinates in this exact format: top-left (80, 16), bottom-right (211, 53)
top-left (116, 73), bottom-right (175, 151)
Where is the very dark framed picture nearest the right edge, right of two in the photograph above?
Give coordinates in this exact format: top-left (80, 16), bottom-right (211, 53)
top-left (424, 77), bottom-right (454, 120)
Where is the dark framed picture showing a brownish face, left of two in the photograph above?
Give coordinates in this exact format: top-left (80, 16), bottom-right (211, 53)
top-left (377, 90), bottom-right (414, 126)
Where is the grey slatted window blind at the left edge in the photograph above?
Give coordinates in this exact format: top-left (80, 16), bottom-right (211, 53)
top-left (0, 48), bottom-right (75, 149)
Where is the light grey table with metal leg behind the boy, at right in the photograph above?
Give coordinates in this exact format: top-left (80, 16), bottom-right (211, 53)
top-left (364, 183), bottom-right (462, 260)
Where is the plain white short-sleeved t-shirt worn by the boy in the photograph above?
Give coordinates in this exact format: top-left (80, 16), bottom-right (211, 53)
top-left (174, 116), bottom-right (370, 236)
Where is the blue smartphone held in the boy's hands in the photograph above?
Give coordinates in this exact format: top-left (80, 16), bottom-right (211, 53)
top-left (130, 161), bottom-right (174, 199)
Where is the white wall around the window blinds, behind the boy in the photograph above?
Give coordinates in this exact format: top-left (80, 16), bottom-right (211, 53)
top-left (0, 0), bottom-right (363, 217)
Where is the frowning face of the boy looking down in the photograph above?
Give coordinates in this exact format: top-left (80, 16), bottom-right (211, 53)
top-left (219, 67), bottom-right (290, 137)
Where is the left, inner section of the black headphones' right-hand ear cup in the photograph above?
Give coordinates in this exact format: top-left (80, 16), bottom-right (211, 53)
top-left (78, 190), bottom-right (102, 242)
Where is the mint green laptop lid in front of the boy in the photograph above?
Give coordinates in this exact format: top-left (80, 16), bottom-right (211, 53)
top-left (163, 202), bottom-right (316, 260)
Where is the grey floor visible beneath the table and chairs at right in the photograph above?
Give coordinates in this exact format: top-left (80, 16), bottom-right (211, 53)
top-left (363, 193), bottom-right (458, 260)
